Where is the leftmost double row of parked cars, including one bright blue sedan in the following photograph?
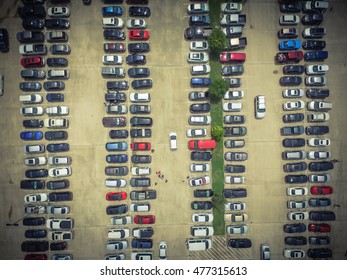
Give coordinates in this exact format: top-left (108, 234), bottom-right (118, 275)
top-left (17, 0), bottom-right (75, 260)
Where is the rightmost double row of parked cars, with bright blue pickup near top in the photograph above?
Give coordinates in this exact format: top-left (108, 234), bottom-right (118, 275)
top-left (275, 1), bottom-right (335, 259)
